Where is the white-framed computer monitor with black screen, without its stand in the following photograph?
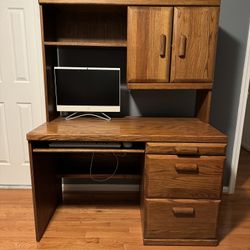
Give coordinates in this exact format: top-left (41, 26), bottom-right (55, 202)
top-left (54, 67), bottom-right (120, 112)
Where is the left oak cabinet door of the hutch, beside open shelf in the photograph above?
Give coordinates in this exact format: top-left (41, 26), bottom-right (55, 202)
top-left (127, 7), bottom-right (173, 82)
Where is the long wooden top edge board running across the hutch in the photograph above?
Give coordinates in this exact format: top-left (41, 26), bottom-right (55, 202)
top-left (39, 0), bottom-right (221, 6)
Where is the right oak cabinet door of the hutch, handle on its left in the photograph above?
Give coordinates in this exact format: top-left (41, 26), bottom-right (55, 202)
top-left (171, 7), bottom-right (219, 82)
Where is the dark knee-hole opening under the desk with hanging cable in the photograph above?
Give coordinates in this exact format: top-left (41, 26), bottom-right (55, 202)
top-left (33, 146), bottom-right (145, 204)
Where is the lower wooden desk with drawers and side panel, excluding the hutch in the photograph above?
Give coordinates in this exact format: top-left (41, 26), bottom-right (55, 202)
top-left (27, 117), bottom-right (226, 245)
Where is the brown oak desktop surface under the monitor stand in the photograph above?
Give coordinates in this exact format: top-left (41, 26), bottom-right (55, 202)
top-left (27, 117), bottom-right (227, 143)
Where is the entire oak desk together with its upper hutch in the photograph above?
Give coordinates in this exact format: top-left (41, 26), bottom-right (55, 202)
top-left (27, 0), bottom-right (227, 245)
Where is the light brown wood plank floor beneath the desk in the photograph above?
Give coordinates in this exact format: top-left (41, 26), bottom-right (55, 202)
top-left (0, 151), bottom-right (250, 250)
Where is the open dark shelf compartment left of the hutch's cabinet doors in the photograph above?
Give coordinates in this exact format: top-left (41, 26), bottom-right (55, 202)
top-left (42, 5), bottom-right (127, 47)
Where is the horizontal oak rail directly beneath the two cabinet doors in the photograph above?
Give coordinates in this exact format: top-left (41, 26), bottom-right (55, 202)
top-left (128, 82), bottom-right (213, 90)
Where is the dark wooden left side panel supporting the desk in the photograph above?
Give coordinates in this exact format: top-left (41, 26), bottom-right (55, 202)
top-left (29, 143), bottom-right (62, 241)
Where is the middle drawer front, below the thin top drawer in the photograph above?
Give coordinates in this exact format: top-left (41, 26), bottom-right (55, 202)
top-left (144, 154), bottom-right (225, 199)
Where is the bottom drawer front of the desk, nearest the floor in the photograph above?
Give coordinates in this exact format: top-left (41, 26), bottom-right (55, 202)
top-left (144, 199), bottom-right (220, 239)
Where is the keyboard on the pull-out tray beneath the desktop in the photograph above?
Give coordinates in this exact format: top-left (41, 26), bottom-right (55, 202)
top-left (49, 141), bottom-right (122, 148)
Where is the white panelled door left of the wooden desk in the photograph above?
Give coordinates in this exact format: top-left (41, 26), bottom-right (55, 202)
top-left (0, 0), bottom-right (45, 185)
